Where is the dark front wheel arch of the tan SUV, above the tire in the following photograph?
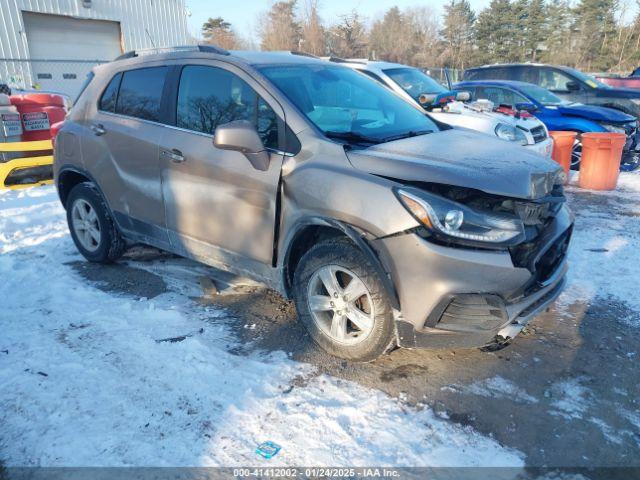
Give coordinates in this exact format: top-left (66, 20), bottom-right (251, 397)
top-left (281, 217), bottom-right (400, 310)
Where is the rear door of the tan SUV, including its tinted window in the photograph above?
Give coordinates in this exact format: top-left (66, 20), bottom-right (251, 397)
top-left (83, 65), bottom-right (169, 246)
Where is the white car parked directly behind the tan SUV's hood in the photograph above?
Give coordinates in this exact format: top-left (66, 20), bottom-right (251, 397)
top-left (329, 57), bottom-right (553, 157)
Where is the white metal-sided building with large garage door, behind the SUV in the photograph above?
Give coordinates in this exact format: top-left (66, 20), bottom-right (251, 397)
top-left (0, 0), bottom-right (192, 97)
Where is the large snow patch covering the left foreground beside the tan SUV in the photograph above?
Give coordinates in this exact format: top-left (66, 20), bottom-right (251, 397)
top-left (0, 187), bottom-right (523, 466)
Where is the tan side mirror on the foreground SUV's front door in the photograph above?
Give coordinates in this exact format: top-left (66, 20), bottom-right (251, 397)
top-left (213, 120), bottom-right (270, 172)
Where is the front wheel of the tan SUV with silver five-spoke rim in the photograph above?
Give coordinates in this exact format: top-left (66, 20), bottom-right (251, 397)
top-left (293, 239), bottom-right (396, 362)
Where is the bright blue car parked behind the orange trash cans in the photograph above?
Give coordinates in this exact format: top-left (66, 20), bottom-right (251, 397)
top-left (453, 80), bottom-right (640, 170)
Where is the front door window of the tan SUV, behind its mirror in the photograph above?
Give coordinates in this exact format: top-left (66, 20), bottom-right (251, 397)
top-left (176, 65), bottom-right (278, 149)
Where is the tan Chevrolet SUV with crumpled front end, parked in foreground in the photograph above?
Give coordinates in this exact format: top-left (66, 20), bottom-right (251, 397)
top-left (54, 46), bottom-right (573, 360)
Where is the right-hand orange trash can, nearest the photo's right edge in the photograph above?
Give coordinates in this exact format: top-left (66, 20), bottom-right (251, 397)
top-left (578, 132), bottom-right (627, 190)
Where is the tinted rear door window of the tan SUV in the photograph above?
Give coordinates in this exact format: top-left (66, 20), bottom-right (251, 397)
top-left (116, 67), bottom-right (168, 122)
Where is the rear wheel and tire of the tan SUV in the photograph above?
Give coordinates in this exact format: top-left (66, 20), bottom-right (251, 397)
top-left (66, 182), bottom-right (127, 263)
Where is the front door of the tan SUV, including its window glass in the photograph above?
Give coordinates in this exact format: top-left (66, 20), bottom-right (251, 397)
top-left (160, 62), bottom-right (284, 270)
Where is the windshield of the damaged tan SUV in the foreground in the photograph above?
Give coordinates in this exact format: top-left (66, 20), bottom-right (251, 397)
top-left (260, 65), bottom-right (438, 143)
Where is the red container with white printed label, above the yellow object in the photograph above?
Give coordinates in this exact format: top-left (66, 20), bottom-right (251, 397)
top-left (10, 93), bottom-right (67, 142)
